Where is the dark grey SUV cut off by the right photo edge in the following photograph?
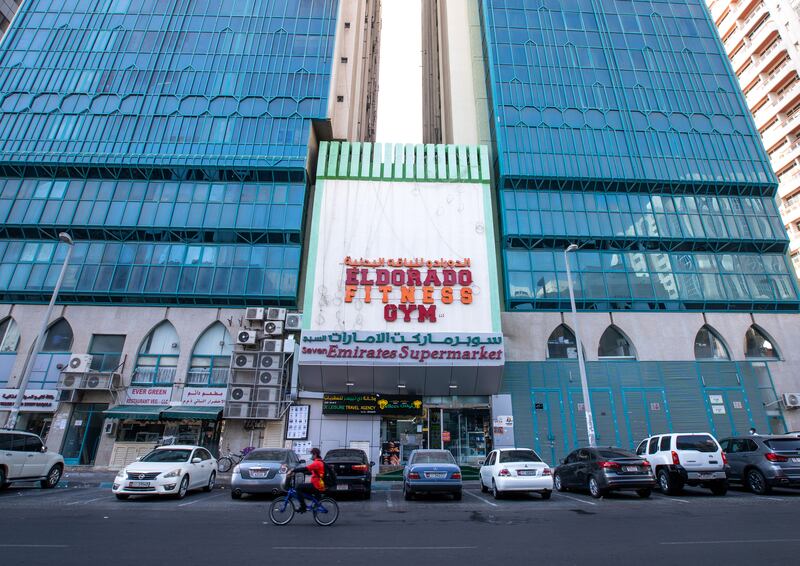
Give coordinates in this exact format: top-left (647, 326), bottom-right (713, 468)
top-left (720, 436), bottom-right (800, 495)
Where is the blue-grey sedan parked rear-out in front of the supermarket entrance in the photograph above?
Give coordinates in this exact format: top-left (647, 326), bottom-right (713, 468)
top-left (403, 450), bottom-right (462, 501)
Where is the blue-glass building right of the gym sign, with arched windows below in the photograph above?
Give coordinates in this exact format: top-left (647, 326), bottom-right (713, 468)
top-left (423, 0), bottom-right (800, 461)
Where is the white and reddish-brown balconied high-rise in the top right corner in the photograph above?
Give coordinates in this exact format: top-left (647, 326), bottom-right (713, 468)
top-left (707, 0), bottom-right (800, 274)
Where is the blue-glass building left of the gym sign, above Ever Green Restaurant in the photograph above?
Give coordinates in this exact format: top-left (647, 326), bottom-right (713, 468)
top-left (0, 0), bottom-right (380, 466)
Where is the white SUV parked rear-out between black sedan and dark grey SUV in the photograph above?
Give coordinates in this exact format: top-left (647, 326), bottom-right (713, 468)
top-left (636, 432), bottom-right (728, 495)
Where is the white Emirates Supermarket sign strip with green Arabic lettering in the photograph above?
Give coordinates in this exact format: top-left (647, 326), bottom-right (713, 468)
top-left (299, 330), bottom-right (505, 366)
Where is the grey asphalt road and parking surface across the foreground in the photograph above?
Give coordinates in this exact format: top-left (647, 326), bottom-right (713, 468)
top-left (0, 484), bottom-right (800, 566)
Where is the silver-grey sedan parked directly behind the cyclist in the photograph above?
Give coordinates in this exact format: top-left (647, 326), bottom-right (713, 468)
top-left (231, 448), bottom-right (300, 499)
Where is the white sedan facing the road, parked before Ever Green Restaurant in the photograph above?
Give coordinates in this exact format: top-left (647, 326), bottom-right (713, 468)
top-left (112, 445), bottom-right (217, 499)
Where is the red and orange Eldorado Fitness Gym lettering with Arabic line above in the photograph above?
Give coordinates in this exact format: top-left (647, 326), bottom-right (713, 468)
top-left (344, 256), bottom-right (473, 323)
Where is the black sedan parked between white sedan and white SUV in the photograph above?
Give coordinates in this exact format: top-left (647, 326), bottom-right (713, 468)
top-left (553, 447), bottom-right (656, 498)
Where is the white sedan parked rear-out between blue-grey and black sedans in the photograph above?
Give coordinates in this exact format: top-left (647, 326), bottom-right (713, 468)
top-left (480, 448), bottom-right (553, 499)
